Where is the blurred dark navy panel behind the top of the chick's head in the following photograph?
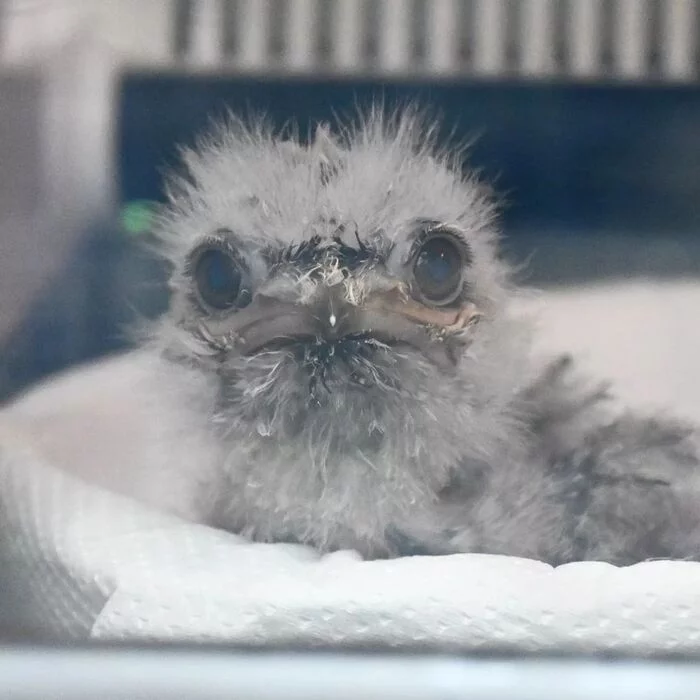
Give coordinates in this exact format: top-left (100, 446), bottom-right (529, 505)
top-left (119, 76), bottom-right (700, 235)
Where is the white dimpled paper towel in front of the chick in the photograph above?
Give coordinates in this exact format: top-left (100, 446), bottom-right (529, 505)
top-left (0, 446), bottom-right (700, 653)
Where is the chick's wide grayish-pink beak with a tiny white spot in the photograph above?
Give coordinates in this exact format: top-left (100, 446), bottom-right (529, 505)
top-left (200, 285), bottom-right (481, 354)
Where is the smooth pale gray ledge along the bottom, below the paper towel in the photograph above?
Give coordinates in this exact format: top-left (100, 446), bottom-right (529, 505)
top-left (0, 648), bottom-right (700, 700)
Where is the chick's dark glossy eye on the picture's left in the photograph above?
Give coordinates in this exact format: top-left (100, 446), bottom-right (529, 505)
top-left (191, 246), bottom-right (251, 311)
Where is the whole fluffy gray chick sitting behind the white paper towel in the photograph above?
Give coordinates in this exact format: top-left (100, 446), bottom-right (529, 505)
top-left (104, 113), bottom-right (700, 564)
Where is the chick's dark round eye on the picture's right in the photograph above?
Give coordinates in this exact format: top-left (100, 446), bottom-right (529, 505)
top-left (413, 233), bottom-right (464, 305)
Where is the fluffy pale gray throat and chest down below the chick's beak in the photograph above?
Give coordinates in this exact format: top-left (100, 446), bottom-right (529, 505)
top-left (178, 336), bottom-right (528, 555)
